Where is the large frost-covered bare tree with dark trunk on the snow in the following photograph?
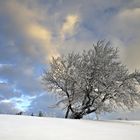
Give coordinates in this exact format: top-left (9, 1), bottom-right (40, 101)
top-left (43, 41), bottom-right (140, 119)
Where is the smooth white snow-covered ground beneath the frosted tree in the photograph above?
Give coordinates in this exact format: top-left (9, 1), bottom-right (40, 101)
top-left (0, 115), bottom-right (140, 140)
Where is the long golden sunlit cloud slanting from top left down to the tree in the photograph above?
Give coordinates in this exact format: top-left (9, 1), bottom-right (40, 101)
top-left (0, 0), bottom-right (59, 61)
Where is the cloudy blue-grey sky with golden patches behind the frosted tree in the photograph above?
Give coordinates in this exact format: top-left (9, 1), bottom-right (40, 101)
top-left (0, 0), bottom-right (140, 118)
